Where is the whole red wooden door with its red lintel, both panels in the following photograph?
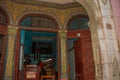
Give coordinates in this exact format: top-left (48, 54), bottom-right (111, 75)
top-left (67, 30), bottom-right (95, 80)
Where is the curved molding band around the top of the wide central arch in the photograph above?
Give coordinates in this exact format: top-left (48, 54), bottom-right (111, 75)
top-left (15, 11), bottom-right (61, 29)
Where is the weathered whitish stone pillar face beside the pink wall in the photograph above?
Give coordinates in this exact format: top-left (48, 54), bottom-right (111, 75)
top-left (94, 0), bottom-right (120, 80)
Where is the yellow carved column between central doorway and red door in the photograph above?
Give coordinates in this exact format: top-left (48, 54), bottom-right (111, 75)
top-left (59, 30), bottom-right (68, 80)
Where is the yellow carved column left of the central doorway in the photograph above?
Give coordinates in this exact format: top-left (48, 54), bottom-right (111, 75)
top-left (4, 26), bottom-right (17, 80)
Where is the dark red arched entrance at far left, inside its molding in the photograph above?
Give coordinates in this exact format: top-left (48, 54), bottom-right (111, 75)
top-left (0, 7), bottom-right (9, 80)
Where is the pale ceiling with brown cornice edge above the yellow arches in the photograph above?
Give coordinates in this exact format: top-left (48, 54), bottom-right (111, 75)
top-left (12, 0), bottom-right (81, 9)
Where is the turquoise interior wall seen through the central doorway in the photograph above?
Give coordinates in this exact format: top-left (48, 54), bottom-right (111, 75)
top-left (20, 30), bottom-right (57, 66)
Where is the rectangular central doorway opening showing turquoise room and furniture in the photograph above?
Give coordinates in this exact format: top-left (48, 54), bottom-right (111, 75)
top-left (19, 30), bottom-right (58, 80)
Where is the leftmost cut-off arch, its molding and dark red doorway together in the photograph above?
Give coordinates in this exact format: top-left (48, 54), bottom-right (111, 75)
top-left (0, 3), bottom-right (13, 80)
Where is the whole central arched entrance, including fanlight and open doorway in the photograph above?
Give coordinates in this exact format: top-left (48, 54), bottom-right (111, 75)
top-left (15, 14), bottom-right (60, 80)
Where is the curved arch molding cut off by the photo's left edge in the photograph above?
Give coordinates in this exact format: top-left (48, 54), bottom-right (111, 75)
top-left (0, 4), bottom-right (14, 25)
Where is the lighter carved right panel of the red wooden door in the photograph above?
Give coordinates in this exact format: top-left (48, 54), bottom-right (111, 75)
top-left (81, 31), bottom-right (95, 80)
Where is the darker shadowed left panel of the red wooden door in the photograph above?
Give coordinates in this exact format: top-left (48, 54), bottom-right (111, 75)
top-left (74, 38), bottom-right (83, 80)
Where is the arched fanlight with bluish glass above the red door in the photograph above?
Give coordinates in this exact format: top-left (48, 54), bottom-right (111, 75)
top-left (67, 14), bottom-right (89, 30)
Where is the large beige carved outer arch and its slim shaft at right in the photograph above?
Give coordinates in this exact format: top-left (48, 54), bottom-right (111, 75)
top-left (75, 0), bottom-right (102, 80)
